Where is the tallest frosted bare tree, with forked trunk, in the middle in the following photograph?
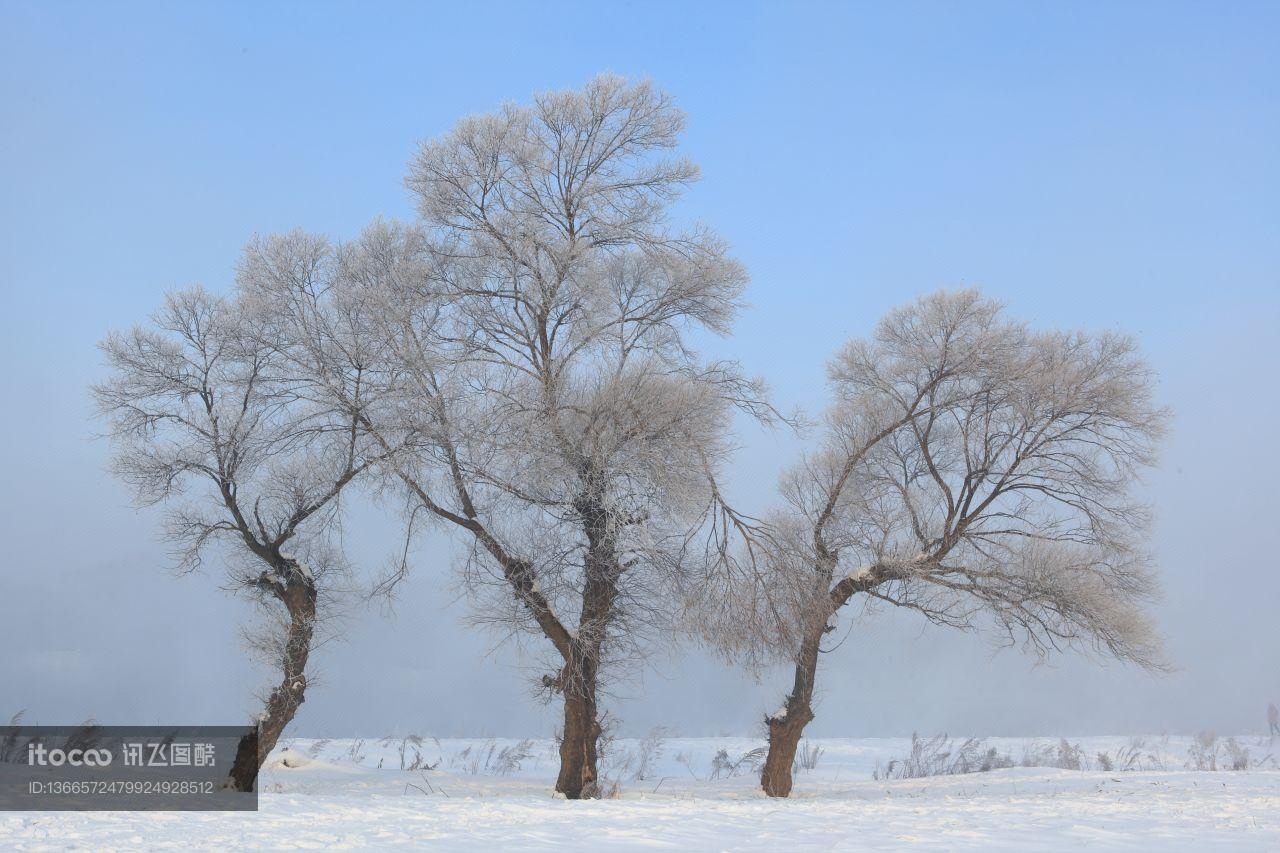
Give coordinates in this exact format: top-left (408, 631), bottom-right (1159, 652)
top-left (241, 76), bottom-right (771, 798)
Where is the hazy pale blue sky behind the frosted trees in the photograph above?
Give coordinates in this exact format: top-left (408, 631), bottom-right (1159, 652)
top-left (0, 0), bottom-right (1280, 734)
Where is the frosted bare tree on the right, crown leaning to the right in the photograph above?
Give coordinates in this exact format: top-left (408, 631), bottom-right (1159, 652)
top-left (703, 291), bottom-right (1167, 797)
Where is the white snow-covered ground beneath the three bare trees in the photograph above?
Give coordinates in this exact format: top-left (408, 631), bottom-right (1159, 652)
top-left (0, 736), bottom-right (1280, 850)
